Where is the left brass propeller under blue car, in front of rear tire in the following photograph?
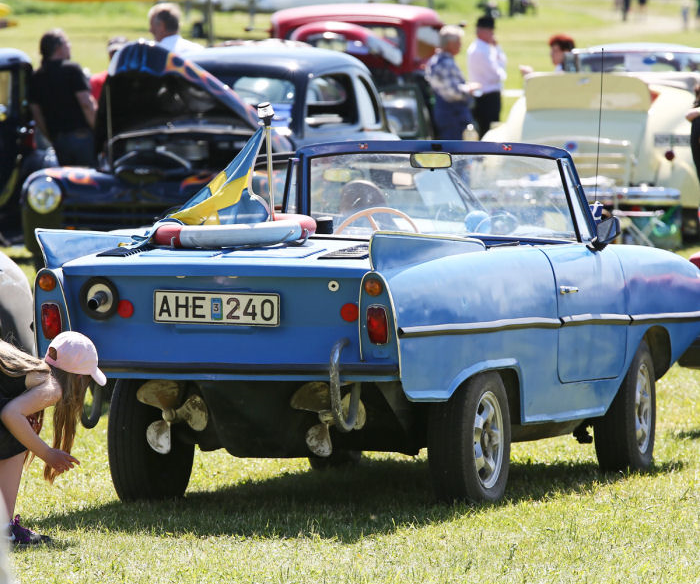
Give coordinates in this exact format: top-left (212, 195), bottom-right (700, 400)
top-left (136, 379), bottom-right (209, 454)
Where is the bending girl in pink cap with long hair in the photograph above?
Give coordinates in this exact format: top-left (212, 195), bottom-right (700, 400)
top-left (0, 331), bottom-right (107, 545)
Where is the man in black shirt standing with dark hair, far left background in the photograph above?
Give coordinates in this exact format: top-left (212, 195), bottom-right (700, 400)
top-left (28, 29), bottom-right (96, 166)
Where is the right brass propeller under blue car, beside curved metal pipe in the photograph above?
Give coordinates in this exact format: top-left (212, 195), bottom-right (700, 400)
top-left (290, 381), bottom-right (367, 458)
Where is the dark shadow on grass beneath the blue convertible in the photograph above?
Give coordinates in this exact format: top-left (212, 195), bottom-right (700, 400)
top-left (31, 460), bottom-right (682, 543)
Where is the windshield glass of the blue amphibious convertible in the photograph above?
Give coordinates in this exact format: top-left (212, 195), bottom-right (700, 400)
top-left (310, 153), bottom-right (579, 241)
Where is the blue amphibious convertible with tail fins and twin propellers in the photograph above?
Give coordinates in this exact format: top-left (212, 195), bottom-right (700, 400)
top-left (35, 136), bottom-right (700, 502)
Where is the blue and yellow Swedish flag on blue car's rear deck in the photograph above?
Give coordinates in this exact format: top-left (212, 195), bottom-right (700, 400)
top-left (170, 126), bottom-right (265, 225)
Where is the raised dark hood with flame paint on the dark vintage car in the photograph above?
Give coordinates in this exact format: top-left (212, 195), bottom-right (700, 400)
top-left (95, 40), bottom-right (291, 151)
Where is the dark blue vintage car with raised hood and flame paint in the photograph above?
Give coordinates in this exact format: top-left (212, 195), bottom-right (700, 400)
top-left (22, 42), bottom-right (393, 255)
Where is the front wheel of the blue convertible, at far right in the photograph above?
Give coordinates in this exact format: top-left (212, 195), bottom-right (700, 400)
top-left (593, 341), bottom-right (656, 471)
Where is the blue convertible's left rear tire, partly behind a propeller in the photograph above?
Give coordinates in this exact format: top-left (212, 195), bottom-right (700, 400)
top-left (107, 379), bottom-right (194, 501)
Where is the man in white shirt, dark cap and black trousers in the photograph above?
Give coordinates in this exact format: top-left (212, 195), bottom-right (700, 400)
top-left (467, 16), bottom-right (506, 138)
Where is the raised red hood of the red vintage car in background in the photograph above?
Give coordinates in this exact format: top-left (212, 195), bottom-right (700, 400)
top-left (291, 20), bottom-right (403, 67)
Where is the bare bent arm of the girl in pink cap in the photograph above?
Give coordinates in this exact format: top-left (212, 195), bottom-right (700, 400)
top-left (0, 375), bottom-right (80, 472)
